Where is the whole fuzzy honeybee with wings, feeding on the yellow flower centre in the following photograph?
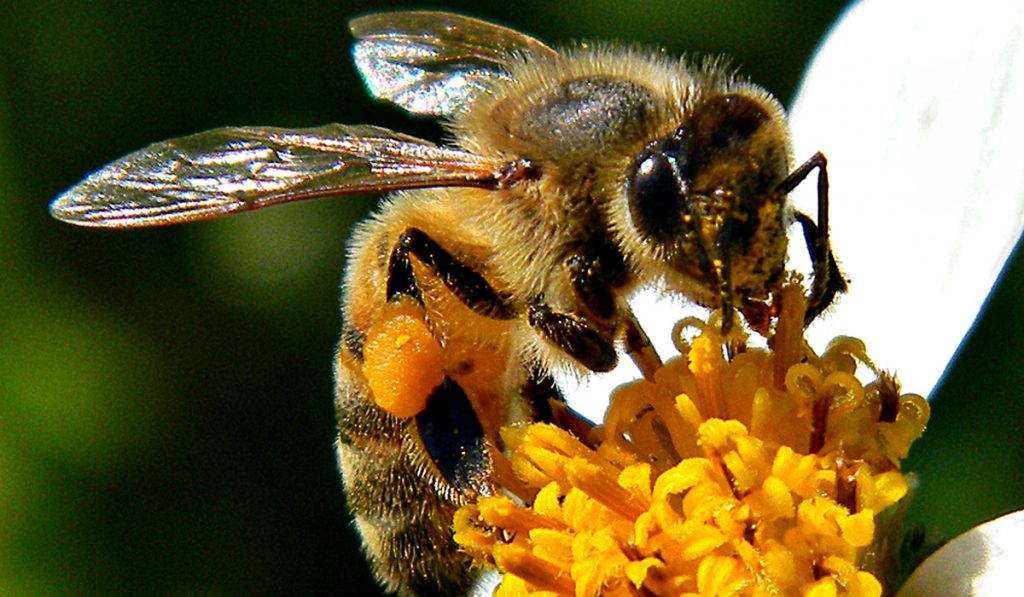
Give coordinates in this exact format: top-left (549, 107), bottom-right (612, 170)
top-left (50, 12), bottom-right (846, 594)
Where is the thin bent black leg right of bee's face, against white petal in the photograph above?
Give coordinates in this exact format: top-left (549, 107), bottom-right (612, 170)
top-left (776, 152), bottom-right (847, 325)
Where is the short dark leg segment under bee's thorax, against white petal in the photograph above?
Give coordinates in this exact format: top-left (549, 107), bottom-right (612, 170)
top-left (529, 303), bottom-right (617, 372)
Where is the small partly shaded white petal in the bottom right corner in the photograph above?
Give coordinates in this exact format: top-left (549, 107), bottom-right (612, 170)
top-left (897, 510), bottom-right (1024, 597)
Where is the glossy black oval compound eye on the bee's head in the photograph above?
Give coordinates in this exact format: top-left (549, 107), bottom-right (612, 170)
top-left (627, 150), bottom-right (686, 243)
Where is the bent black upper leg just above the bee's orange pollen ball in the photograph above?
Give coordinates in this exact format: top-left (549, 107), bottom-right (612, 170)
top-left (387, 228), bottom-right (517, 319)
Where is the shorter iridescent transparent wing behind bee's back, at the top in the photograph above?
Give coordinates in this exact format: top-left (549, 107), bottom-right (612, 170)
top-left (349, 12), bottom-right (554, 116)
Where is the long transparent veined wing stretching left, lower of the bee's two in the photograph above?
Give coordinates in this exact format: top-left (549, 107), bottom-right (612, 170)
top-left (50, 124), bottom-right (504, 227)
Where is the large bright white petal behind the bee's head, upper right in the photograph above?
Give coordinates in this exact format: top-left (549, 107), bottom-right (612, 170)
top-left (792, 0), bottom-right (1024, 395)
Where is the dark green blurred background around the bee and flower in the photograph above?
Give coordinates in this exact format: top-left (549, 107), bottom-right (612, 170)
top-left (0, 0), bottom-right (1024, 595)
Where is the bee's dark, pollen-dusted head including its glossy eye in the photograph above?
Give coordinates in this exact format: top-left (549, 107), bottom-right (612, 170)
top-left (626, 90), bottom-right (790, 322)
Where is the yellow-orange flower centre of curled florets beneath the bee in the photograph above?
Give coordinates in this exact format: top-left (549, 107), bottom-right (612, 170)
top-left (456, 284), bottom-right (929, 596)
